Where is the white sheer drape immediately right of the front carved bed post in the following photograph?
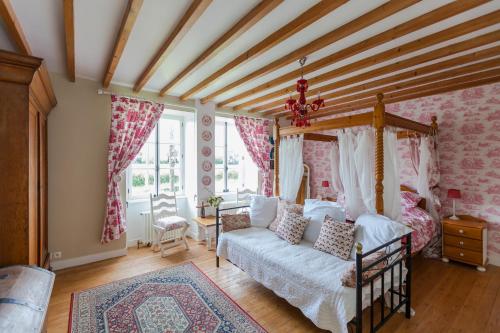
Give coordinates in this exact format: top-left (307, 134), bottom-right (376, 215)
top-left (383, 128), bottom-right (402, 221)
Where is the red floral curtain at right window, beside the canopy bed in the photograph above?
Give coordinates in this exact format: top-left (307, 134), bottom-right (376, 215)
top-left (234, 116), bottom-right (273, 197)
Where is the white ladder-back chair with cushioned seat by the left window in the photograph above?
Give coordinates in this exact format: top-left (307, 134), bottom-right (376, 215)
top-left (149, 193), bottom-right (189, 257)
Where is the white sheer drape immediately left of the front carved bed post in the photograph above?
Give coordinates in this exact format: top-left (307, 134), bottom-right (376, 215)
top-left (354, 128), bottom-right (376, 213)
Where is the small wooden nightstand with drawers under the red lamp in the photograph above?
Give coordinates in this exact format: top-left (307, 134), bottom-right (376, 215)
top-left (442, 215), bottom-right (488, 272)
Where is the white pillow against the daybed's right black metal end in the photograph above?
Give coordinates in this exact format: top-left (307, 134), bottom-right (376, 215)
top-left (351, 213), bottom-right (412, 259)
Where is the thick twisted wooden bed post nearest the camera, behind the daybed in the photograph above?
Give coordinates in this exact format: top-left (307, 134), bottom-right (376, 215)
top-left (373, 93), bottom-right (385, 215)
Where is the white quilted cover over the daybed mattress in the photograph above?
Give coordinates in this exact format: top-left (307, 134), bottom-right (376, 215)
top-left (217, 227), bottom-right (406, 333)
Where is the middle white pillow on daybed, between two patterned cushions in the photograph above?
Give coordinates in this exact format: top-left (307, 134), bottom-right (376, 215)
top-left (304, 199), bottom-right (345, 243)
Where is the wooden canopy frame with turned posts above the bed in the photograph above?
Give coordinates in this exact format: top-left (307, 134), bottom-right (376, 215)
top-left (273, 93), bottom-right (438, 215)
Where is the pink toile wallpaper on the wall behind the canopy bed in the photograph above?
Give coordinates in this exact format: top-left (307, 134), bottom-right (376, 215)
top-left (304, 83), bottom-right (500, 265)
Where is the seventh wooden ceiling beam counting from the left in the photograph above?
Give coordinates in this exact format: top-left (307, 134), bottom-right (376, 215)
top-left (209, 0), bottom-right (419, 107)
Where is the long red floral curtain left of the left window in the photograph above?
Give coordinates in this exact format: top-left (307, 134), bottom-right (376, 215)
top-left (101, 95), bottom-right (164, 243)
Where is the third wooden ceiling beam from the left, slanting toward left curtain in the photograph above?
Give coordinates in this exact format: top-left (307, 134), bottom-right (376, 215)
top-left (102, 0), bottom-right (144, 88)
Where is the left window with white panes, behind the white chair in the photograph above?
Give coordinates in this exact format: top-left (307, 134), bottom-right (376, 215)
top-left (127, 115), bottom-right (184, 200)
